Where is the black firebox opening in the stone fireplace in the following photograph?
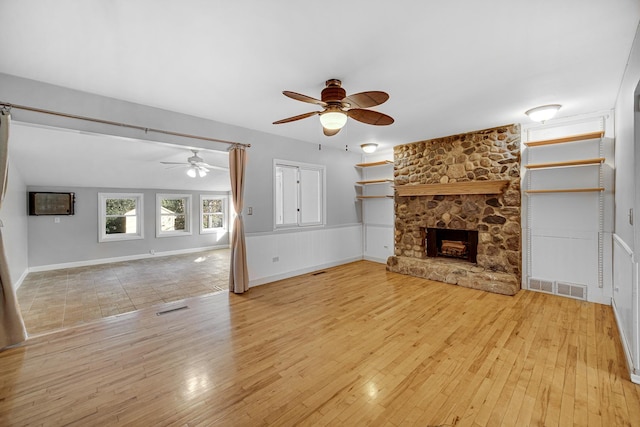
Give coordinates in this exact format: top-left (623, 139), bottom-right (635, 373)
top-left (425, 228), bottom-right (478, 264)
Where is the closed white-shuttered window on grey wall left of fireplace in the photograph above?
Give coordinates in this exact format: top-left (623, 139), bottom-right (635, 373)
top-left (274, 160), bottom-right (325, 228)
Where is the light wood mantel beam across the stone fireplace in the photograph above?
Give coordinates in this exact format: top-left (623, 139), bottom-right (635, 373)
top-left (395, 179), bottom-right (511, 196)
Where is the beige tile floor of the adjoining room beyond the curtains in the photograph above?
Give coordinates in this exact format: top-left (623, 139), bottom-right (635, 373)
top-left (17, 249), bottom-right (229, 336)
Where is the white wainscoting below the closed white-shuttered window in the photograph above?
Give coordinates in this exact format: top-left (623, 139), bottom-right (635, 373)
top-left (245, 224), bottom-right (363, 286)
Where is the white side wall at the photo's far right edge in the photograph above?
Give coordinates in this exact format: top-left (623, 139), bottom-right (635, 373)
top-left (613, 21), bottom-right (640, 383)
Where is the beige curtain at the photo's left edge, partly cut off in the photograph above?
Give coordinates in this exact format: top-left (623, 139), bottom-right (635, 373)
top-left (0, 111), bottom-right (27, 348)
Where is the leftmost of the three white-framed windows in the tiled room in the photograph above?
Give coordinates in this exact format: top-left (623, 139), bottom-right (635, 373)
top-left (98, 193), bottom-right (144, 242)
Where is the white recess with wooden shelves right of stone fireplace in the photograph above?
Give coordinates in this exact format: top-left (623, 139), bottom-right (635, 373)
top-left (522, 121), bottom-right (610, 292)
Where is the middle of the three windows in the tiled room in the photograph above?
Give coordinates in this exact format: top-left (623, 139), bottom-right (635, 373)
top-left (156, 194), bottom-right (191, 237)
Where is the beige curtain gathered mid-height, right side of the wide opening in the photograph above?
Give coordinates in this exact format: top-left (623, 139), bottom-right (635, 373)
top-left (229, 145), bottom-right (249, 294)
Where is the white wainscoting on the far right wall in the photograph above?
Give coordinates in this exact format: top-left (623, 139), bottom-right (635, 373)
top-left (613, 235), bottom-right (640, 383)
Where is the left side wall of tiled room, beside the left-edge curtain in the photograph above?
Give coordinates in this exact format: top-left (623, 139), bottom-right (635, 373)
top-left (0, 160), bottom-right (28, 289)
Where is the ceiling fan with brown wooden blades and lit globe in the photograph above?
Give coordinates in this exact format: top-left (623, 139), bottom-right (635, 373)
top-left (273, 79), bottom-right (393, 136)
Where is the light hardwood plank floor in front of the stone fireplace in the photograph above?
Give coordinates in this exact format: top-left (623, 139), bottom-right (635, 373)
top-left (0, 261), bottom-right (640, 427)
